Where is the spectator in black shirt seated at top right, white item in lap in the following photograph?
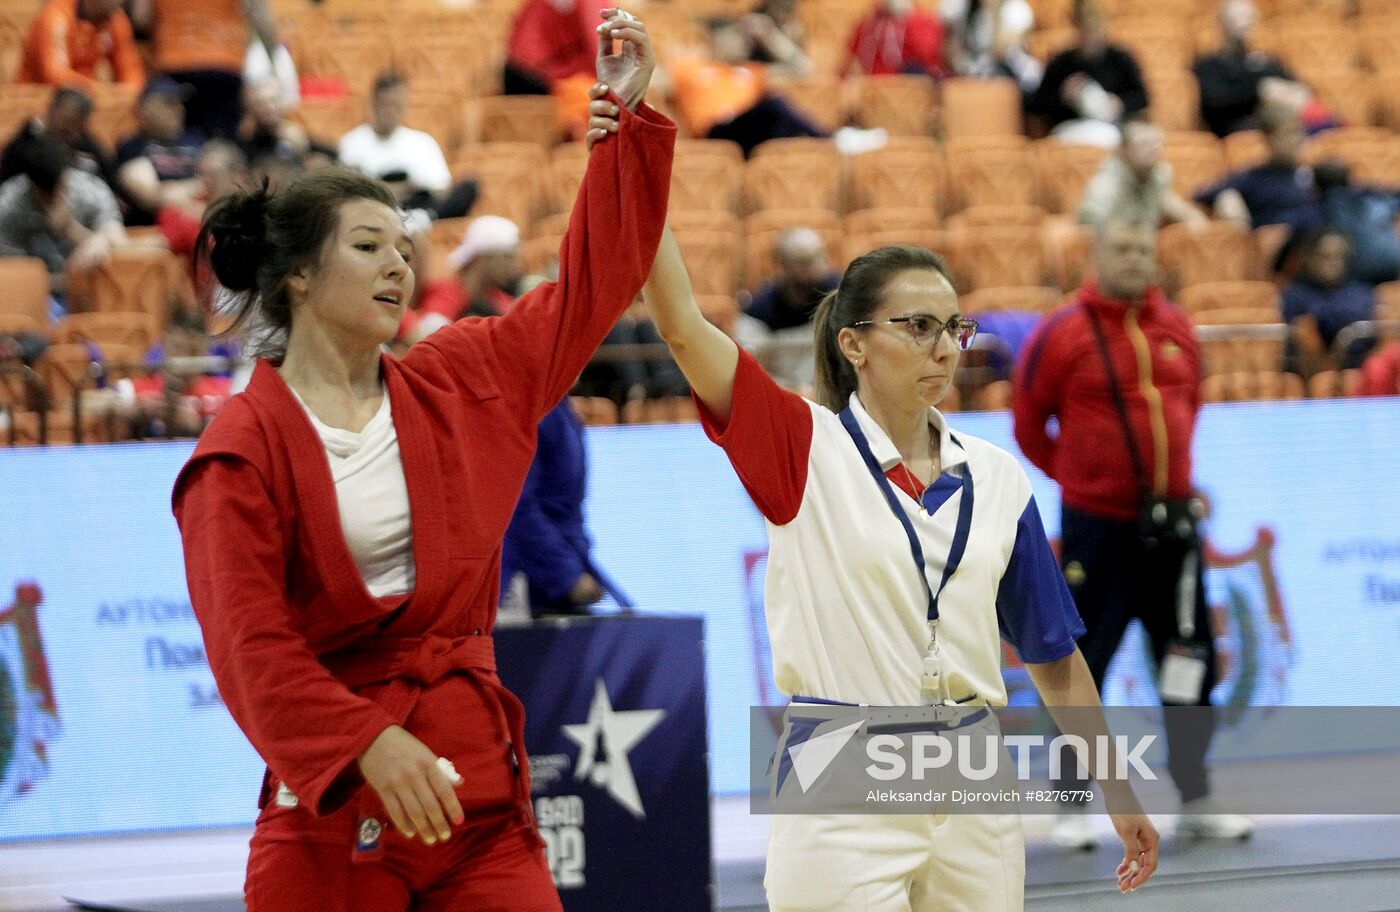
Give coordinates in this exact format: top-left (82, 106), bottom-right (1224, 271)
top-left (1028, 0), bottom-right (1148, 146)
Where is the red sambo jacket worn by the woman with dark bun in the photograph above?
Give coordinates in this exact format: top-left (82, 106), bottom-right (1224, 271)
top-left (174, 99), bottom-right (675, 814)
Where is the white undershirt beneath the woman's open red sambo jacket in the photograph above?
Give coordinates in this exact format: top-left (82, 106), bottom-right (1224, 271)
top-left (293, 389), bottom-right (414, 598)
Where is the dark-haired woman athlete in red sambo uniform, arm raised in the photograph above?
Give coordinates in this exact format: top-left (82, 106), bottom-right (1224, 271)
top-left (172, 11), bottom-right (675, 912)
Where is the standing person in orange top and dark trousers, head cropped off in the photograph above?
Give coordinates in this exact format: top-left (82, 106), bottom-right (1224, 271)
top-left (132, 0), bottom-right (280, 139)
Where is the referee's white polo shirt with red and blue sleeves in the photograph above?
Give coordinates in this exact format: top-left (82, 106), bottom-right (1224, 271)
top-left (700, 352), bottom-right (1084, 706)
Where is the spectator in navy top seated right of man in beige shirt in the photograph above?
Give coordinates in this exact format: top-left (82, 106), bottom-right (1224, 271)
top-left (1196, 105), bottom-right (1322, 230)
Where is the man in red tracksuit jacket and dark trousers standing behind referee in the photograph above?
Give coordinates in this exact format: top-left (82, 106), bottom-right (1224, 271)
top-left (1012, 221), bottom-right (1253, 848)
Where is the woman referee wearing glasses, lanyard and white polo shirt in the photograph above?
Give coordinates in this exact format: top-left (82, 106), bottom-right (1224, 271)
top-left (589, 85), bottom-right (1158, 912)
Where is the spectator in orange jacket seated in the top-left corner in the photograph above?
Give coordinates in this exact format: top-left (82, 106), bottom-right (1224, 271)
top-left (14, 0), bottom-right (146, 91)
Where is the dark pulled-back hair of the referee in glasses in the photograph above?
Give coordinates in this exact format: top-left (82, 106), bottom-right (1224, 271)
top-left (812, 247), bottom-right (952, 412)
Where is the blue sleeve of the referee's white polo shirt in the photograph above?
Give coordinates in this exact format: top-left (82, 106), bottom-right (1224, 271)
top-left (997, 496), bottom-right (1084, 664)
